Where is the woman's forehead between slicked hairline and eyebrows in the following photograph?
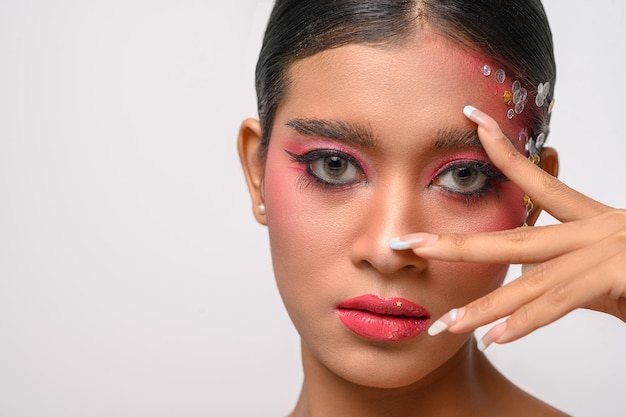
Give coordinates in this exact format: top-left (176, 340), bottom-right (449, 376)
top-left (279, 29), bottom-right (524, 141)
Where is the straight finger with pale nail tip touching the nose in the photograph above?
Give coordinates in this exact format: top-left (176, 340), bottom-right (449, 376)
top-left (390, 210), bottom-right (626, 264)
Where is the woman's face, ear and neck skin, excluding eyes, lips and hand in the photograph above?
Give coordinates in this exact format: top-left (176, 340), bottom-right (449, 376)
top-left (239, 29), bottom-right (562, 416)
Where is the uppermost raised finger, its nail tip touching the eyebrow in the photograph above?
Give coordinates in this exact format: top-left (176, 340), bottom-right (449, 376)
top-left (463, 106), bottom-right (609, 222)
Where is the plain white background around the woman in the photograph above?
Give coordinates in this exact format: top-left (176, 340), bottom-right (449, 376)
top-left (0, 0), bottom-right (626, 417)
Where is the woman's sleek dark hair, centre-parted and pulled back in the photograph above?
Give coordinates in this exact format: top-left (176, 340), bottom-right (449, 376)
top-left (256, 0), bottom-right (556, 158)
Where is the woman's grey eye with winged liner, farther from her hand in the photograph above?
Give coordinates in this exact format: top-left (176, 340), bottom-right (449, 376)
top-left (287, 149), bottom-right (365, 186)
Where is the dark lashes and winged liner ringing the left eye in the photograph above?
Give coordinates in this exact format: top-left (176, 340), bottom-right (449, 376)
top-left (285, 149), bottom-right (366, 191)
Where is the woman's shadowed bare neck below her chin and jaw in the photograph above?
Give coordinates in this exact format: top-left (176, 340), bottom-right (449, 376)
top-left (291, 339), bottom-right (516, 417)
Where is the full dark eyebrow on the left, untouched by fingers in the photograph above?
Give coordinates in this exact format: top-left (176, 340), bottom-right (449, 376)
top-left (285, 119), bottom-right (376, 148)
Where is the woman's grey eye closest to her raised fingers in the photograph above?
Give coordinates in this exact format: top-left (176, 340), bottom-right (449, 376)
top-left (431, 161), bottom-right (506, 196)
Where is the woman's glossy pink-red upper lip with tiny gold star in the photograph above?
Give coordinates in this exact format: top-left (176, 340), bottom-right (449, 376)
top-left (337, 294), bottom-right (430, 317)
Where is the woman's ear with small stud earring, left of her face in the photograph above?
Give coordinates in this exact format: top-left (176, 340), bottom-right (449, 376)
top-left (237, 119), bottom-right (267, 226)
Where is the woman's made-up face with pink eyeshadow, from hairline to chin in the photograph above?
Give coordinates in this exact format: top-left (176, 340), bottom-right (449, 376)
top-left (256, 31), bottom-right (525, 388)
